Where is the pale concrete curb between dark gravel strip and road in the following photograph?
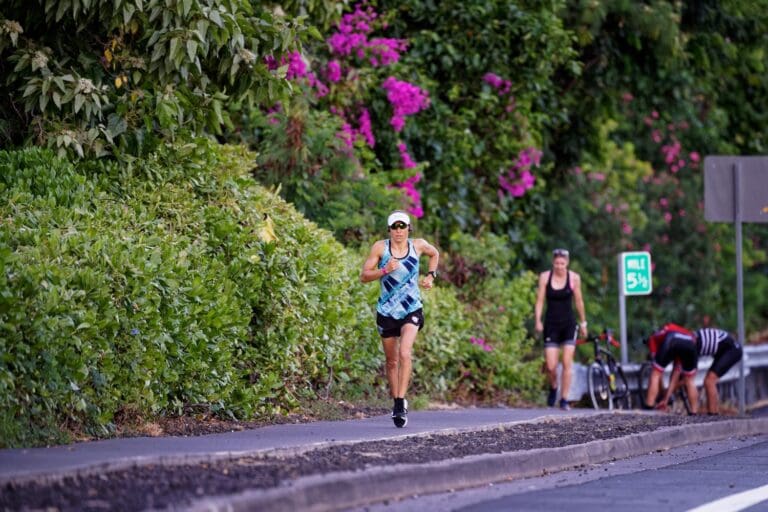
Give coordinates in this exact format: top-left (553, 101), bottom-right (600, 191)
top-left (184, 418), bottom-right (768, 512)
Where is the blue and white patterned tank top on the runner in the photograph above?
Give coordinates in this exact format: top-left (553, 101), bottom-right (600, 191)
top-left (376, 240), bottom-right (422, 320)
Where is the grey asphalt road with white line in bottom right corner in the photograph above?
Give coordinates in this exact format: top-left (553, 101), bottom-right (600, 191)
top-left (356, 434), bottom-right (768, 512)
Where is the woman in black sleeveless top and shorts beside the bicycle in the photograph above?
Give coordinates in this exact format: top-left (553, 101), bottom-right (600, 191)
top-left (534, 249), bottom-right (587, 411)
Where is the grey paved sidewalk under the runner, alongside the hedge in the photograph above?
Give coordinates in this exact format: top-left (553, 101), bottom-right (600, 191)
top-left (0, 408), bottom-right (599, 485)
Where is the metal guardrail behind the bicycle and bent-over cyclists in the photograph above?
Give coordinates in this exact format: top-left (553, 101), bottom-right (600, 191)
top-left (558, 343), bottom-right (768, 401)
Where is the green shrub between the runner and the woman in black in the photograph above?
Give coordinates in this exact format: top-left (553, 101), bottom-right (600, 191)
top-left (438, 233), bottom-right (541, 401)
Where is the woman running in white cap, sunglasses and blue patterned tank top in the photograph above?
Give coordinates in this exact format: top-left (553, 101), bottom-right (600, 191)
top-left (360, 210), bottom-right (440, 428)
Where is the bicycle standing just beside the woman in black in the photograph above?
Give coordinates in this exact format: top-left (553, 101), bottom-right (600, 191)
top-left (576, 329), bottom-right (632, 411)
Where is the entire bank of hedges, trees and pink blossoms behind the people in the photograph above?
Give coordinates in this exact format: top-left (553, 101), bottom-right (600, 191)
top-left (0, 0), bottom-right (768, 446)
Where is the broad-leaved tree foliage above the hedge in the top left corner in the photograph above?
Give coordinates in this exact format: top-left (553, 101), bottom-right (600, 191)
top-left (0, 0), bottom-right (337, 156)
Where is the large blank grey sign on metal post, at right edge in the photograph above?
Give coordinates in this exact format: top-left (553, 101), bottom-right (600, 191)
top-left (704, 156), bottom-right (768, 415)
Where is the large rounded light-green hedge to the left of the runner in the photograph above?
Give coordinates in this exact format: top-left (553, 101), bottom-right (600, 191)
top-left (0, 142), bottom-right (379, 445)
